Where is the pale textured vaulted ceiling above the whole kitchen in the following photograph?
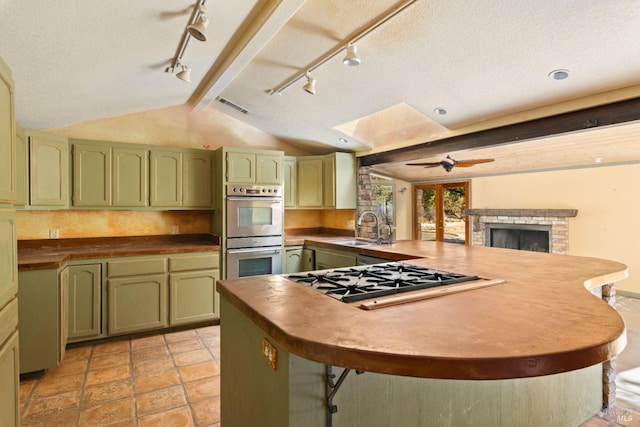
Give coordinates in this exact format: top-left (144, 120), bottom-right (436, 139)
top-left (0, 0), bottom-right (640, 181)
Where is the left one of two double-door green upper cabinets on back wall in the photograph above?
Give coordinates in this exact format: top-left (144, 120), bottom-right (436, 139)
top-left (73, 143), bottom-right (149, 207)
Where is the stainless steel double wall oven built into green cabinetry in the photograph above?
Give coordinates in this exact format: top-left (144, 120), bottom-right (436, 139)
top-left (226, 184), bottom-right (284, 279)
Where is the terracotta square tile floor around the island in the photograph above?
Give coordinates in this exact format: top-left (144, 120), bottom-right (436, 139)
top-left (20, 297), bottom-right (640, 427)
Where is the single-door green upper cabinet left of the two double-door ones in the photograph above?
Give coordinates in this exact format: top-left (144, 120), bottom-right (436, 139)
top-left (25, 130), bottom-right (69, 209)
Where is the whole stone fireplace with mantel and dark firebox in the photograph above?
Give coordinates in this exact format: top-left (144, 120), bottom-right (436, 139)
top-left (465, 209), bottom-right (578, 254)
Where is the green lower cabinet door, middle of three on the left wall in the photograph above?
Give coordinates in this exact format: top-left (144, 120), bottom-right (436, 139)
top-left (108, 274), bottom-right (168, 335)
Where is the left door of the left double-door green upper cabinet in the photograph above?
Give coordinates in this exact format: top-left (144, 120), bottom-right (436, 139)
top-left (73, 144), bottom-right (112, 207)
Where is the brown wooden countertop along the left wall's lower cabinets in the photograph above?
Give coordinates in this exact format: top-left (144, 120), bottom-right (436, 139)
top-left (18, 234), bottom-right (220, 271)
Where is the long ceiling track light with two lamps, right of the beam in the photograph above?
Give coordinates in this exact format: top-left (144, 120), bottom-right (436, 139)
top-left (269, 0), bottom-right (418, 95)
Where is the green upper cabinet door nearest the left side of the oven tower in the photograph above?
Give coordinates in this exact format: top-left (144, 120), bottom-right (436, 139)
top-left (182, 152), bottom-right (212, 208)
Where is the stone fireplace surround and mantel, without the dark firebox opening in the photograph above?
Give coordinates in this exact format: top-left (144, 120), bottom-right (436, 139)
top-left (465, 209), bottom-right (578, 254)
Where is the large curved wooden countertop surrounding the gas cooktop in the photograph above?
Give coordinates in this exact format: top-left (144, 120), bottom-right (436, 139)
top-left (218, 241), bottom-right (627, 379)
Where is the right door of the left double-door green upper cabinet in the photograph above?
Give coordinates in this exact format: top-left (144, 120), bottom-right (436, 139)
top-left (112, 148), bottom-right (149, 207)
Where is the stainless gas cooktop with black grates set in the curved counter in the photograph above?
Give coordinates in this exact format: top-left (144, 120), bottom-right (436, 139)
top-left (285, 262), bottom-right (479, 303)
